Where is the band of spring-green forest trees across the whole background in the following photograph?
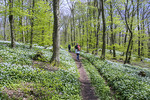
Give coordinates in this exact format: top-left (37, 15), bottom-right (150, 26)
top-left (0, 0), bottom-right (150, 63)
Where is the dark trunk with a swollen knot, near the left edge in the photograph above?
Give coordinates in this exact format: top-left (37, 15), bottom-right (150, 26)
top-left (9, 0), bottom-right (16, 48)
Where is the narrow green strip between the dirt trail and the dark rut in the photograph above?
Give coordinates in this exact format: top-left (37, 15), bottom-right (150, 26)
top-left (82, 59), bottom-right (113, 100)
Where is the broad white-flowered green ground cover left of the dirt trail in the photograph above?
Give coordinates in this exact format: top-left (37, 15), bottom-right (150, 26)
top-left (0, 42), bottom-right (81, 100)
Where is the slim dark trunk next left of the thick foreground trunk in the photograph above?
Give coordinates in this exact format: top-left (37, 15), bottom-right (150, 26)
top-left (30, 0), bottom-right (35, 49)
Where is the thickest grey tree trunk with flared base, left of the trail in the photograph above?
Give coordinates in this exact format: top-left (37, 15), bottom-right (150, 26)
top-left (50, 0), bottom-right (60, 66)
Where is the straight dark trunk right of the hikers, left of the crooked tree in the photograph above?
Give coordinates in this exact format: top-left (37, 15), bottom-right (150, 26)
top-left (101, 0), bottom-right (106, 59)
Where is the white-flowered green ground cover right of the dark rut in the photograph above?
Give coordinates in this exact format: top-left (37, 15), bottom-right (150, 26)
top-left (81, 53), bottom-right (150, 100)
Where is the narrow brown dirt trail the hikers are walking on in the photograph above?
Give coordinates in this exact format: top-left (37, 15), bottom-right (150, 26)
top-left (71, 53), bottom-right (98, 100)
